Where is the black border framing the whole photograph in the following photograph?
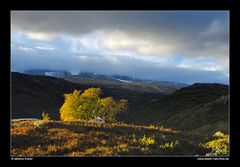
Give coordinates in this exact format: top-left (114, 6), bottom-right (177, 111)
top-left (0, 0), bottom-right (240, 162)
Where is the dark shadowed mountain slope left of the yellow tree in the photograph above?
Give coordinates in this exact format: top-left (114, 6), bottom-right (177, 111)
top-left (11, 72), bottom-right (80, 119)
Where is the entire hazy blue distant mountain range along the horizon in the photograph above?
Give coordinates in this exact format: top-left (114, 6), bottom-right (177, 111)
top-left (20, 69), bottom-right (189, 94)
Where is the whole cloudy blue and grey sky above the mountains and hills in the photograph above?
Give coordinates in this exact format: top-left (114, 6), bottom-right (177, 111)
top-left (11, 11), bottom-right (229, 84)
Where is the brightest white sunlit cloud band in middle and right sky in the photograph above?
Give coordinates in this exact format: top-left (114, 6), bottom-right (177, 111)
top-left (60, 30), bottom-right (228, 72)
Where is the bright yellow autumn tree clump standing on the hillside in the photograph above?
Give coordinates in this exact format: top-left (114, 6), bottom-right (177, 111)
top-left (60, 88), bottom-right (128, 122)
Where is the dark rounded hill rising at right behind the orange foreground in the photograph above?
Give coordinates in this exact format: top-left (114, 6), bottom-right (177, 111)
top-left (125, 83), bottom-right (229, 133)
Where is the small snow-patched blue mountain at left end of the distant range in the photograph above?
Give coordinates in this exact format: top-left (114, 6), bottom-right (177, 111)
top-left (23, 69), bottom-right (72, 77)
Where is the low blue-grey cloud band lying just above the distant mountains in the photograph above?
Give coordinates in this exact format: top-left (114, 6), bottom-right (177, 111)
top-left (11, 43), bottom-right (228, 84)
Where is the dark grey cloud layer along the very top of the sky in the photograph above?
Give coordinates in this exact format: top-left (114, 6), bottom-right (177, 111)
top-left (11, 11), bottom-right (228, 34)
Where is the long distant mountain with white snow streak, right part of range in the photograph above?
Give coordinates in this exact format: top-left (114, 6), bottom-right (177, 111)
top-left (62, 73), bottom-right (187, 94)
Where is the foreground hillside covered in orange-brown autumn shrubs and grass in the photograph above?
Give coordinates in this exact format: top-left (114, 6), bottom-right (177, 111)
top-left (11, 120), bottom-right (210, 157)
